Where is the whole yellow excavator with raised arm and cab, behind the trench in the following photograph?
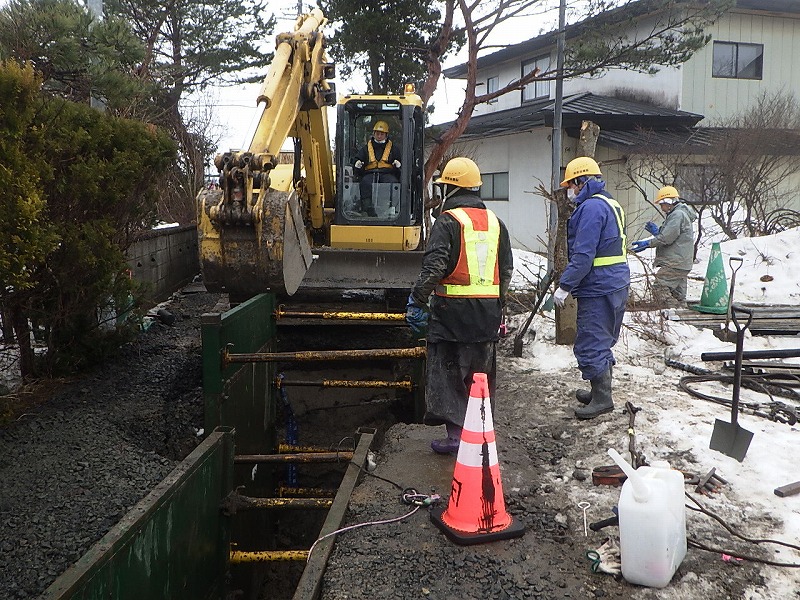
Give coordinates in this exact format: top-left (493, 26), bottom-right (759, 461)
top-left (197, 9), bottom-right (424, 301)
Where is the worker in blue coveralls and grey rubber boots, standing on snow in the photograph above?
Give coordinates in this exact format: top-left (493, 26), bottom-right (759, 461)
top-left (553, 156), bottom-right (631, 419)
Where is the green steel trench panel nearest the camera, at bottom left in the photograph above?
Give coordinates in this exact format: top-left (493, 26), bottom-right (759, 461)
top-left (41, 429), bottom-right (234, 600)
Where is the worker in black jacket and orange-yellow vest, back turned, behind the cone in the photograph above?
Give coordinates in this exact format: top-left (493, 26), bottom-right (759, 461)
top-left (406, 157), bottom-right (514, 454)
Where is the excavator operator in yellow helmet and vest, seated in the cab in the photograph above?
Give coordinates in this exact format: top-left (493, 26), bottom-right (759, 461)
top-left (353, 121), bottom-right (402, 217)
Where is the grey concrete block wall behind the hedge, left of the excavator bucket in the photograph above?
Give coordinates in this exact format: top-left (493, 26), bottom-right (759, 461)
top-left (127, 225), bottom-right (200, 304)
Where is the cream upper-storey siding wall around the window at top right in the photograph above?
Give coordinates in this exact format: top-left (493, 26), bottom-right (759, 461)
top-left (680, 13), bottom-right (800, 122)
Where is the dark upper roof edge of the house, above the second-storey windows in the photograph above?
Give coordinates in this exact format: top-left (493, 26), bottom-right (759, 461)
top-left (442, 0), bottom-right (800, 79)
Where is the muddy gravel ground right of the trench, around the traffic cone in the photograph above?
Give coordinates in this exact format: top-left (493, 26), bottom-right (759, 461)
top-left (322, 339), bottom-right (780, 600)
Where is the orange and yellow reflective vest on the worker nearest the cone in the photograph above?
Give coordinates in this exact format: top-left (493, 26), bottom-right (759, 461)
top-left (435, 208), bottom-right (500, 298)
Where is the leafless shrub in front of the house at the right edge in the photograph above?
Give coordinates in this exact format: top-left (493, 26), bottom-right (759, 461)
top-left (628, 92), bottom-right (800, 245)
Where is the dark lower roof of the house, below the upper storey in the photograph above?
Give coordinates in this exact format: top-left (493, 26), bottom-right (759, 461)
top-left (438, 93), bottom-right (703, 140)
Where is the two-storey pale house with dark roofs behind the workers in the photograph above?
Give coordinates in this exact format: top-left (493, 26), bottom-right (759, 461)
top-left (434, 0), bottom-right (800, 252)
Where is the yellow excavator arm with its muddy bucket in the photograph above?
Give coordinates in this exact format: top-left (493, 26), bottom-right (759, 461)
top-left (197, 9), bottom-right (336, 298)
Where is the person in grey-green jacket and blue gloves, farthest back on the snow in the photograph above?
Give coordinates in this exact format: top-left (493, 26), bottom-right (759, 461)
top-left (631, 185), bottom-right (697, 308)
